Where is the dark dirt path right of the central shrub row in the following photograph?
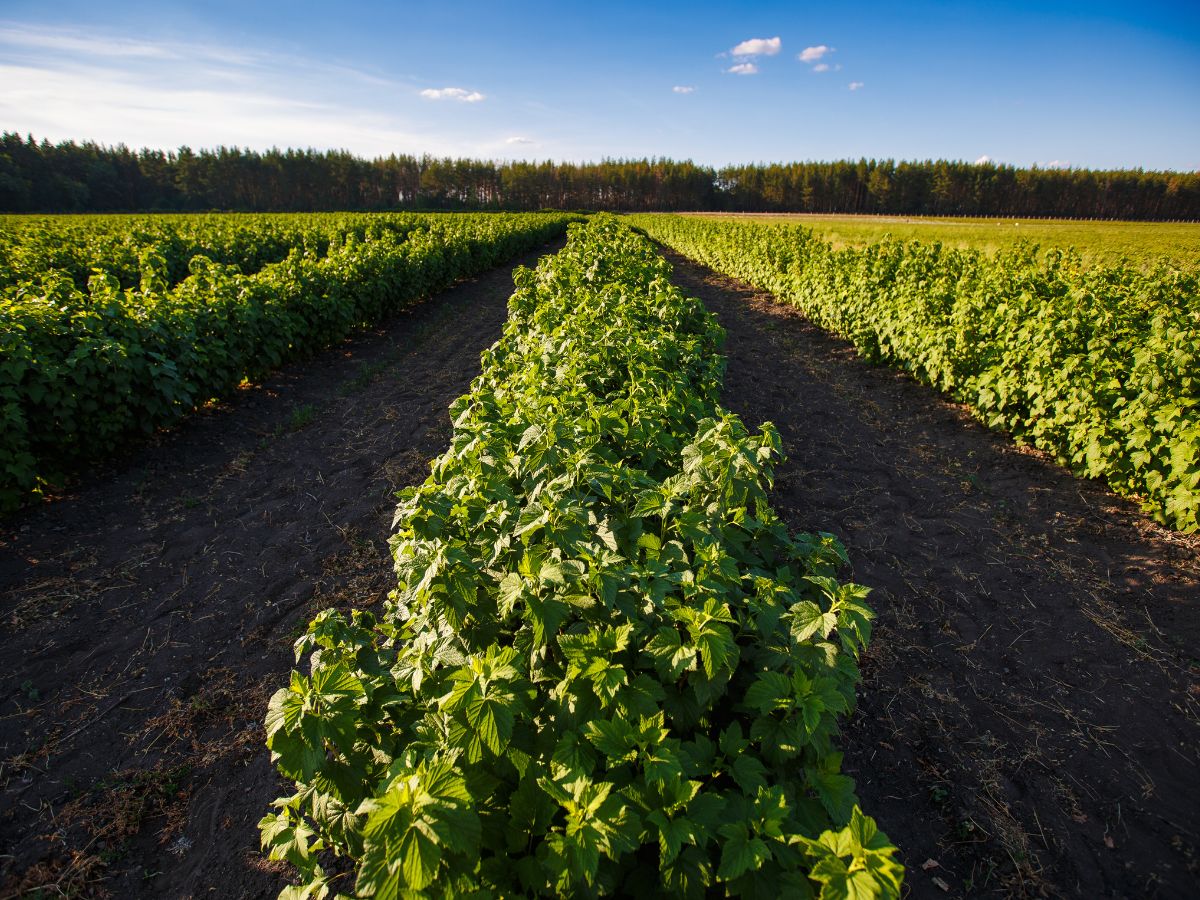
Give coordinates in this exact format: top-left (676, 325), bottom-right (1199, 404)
top-left (668, 248), bottom-right (1200, 898)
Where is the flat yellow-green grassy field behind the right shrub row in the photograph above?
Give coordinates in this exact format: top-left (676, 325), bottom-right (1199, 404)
top-left (684, 212), bottom-right (1200, 268)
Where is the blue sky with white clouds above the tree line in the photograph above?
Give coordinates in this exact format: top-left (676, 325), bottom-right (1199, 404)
top-left (0, 0), bottom-right (1200, 170)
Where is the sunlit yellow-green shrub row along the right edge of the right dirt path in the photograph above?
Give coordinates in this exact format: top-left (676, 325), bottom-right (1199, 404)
top-left (634, 216), bottom-right (1200, 532)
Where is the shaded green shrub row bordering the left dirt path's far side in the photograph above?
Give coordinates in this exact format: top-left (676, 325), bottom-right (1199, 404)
top-left (0, 215), bottom-right (572, 509)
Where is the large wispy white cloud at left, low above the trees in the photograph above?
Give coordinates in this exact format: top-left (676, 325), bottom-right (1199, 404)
top-left (0, 22), bottom-right (481, 156)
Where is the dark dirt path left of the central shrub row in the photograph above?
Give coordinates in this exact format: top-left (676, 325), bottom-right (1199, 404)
top-left (0, 245), bottom-right (558, 899)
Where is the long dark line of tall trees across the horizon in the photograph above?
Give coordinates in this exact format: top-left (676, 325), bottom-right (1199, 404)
top-left (0, 132), bottom-right (1200, 220)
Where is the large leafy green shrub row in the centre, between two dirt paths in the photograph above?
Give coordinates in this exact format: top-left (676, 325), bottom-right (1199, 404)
top-left (260, 216), bottom-right (904, 900)
